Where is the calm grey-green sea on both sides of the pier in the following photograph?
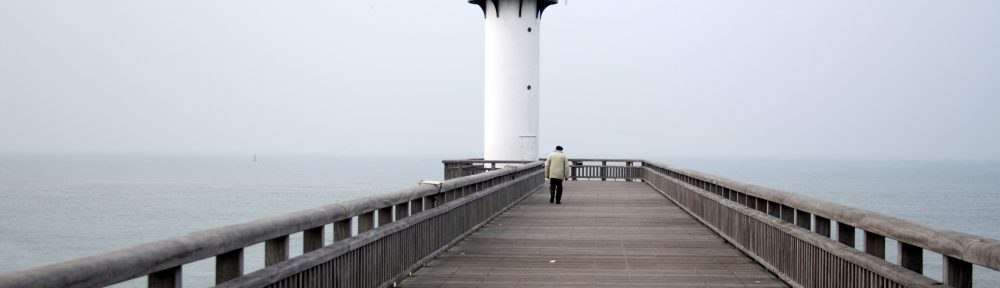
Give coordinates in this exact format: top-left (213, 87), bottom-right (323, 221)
top-left (0, 155), bottom-right (1000, 287)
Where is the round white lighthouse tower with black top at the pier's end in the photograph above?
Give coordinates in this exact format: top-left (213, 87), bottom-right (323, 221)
top-left (469, 0), bottom-right (557, 160)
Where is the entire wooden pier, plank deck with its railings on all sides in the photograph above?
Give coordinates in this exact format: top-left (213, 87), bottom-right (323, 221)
top-left (0, 159), bottom-right (1000, 288)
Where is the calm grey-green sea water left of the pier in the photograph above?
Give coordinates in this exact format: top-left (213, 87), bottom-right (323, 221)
top-left (0, 155), bottom-right (443, 287)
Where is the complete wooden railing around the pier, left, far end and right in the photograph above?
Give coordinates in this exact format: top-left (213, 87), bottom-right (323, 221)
top-left (0, 159), bottom-right (1000, 288)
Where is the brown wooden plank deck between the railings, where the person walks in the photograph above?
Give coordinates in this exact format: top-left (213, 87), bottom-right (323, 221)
top-left (399, 181), bottom-right (788, 287)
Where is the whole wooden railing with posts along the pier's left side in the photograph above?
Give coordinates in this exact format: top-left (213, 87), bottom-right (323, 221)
top-left (0, 162), bottom-right (544, 288)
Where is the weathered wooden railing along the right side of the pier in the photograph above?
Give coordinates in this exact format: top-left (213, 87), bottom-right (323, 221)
top-left (643, 161), bottom-right (1000, 287)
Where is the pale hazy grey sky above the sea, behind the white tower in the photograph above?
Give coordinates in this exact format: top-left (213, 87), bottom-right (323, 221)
top-left (0, 0), bottom-right (1000, 159)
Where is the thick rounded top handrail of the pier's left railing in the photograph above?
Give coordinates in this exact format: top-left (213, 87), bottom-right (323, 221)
top-left (0, 162), bottom-right (543, 288)
